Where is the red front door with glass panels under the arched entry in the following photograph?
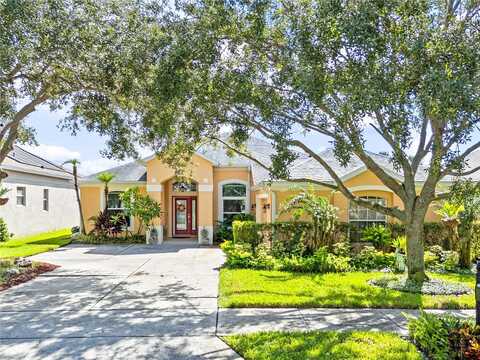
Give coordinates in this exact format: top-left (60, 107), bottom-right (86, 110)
top-left (173, 196), bottom-right (197, 236)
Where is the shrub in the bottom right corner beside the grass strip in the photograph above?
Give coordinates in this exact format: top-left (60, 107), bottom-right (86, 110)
top-left (408, 312), bottom-right (480, 360)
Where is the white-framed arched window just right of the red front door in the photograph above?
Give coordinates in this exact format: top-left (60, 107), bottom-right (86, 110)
top-left (218, 180), bottom-right (250, 222)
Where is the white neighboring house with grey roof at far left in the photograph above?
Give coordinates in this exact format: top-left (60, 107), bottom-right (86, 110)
top-left (0, 145), bottom-right (79, 236)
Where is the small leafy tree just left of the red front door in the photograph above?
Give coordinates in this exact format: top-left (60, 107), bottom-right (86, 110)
top-left (120, 186), bottom-right (162, 235)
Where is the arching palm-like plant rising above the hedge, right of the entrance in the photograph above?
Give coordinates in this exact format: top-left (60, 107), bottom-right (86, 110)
top-left (280, 189), bottom-right (338, 251)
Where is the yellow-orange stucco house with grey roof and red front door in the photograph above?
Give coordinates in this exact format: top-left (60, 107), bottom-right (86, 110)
top-left (80, 138), bottom-right (464, 243)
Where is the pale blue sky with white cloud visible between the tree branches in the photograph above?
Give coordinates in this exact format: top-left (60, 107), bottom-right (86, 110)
top-left (21, 106), bottom-right (480, 176)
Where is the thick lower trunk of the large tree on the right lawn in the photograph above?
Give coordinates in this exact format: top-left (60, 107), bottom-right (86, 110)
top-left (405, 212), bottom-right (427, 282)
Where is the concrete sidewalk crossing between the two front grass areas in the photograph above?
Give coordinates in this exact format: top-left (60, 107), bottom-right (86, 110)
top-left (217, 308), bottom-right (475, 336)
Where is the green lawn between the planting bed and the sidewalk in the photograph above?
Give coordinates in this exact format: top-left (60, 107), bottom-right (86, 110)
top-left (220, 269), bottom-right (475, 309)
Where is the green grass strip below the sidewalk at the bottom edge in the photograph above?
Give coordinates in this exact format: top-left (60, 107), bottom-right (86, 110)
top-left (224, 331), bottom-right (422, 360)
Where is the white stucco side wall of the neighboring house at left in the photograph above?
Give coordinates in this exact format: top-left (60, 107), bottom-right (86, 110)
top-left (0, 171), bottom-right (79, 236)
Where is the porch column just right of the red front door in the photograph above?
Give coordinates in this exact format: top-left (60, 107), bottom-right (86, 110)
top-left (198, 184), bottom-right (213, 245)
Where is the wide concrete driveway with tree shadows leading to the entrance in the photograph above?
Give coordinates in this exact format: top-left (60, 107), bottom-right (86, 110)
top-left (0, 241), bottom-right (238, 359)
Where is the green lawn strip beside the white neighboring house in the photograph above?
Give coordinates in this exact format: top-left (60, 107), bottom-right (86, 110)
top-left (0, 229), bottom-right (71, 258)
